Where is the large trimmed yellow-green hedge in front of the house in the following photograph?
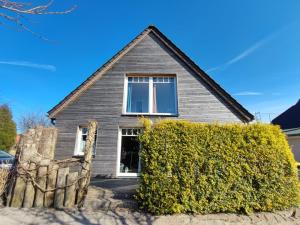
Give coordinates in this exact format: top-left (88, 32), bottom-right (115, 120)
top-left (136, 120), bottom-right (299, 214)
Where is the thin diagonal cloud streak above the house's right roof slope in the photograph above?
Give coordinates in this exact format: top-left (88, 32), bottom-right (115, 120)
top-left (206, 28), bottom-right (285, 72)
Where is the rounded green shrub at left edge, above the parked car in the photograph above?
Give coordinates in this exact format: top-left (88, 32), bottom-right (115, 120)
top-left (0, 105), bottom-right (17, 151)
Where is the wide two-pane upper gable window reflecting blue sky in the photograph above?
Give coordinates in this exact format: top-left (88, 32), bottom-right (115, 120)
top-left (124, 76), bottom-right (177, 115)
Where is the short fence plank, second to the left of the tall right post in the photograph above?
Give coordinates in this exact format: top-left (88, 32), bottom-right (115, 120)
top-left (54, 167), bottom-right (69, 208)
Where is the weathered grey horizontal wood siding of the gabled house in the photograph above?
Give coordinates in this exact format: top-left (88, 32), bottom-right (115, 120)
top-left (56, 33), bottom-right (241, 177)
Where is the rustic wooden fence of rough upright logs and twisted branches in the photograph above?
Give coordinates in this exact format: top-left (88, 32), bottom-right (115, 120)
top-left (6, 121), bottom-right (97, 208)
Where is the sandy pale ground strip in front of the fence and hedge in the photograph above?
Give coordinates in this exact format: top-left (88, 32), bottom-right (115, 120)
top-left (0, 208), bottom-right (300, 225)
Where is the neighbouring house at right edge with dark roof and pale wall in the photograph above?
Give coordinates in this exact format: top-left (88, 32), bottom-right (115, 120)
top-left (272, 100), bottom-right (300, 162)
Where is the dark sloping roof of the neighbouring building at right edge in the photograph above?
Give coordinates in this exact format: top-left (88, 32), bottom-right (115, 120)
top-left (272, 100), bottom-right (300, 130)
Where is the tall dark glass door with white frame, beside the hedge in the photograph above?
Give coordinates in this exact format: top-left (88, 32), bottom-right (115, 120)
top-left (117, 128), bottom-right (141, 176)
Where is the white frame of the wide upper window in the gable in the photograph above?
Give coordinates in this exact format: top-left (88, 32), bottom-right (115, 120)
top-left (122, 74), bottom-right (178, 116)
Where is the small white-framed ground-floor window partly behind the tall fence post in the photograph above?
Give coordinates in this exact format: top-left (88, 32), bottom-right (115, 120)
top-left (74, 126), bottom-right (97, 156)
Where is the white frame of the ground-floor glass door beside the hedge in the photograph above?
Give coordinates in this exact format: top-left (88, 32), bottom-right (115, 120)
top-left (116, 127), bottom-right (142, 177)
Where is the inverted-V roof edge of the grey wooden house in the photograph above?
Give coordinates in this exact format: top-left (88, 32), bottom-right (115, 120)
top-left (48, 26), bottom-right (254, 122)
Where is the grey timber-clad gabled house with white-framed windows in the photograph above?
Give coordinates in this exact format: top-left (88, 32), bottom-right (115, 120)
top-left (48, 26), bottom-right (253, 177)
